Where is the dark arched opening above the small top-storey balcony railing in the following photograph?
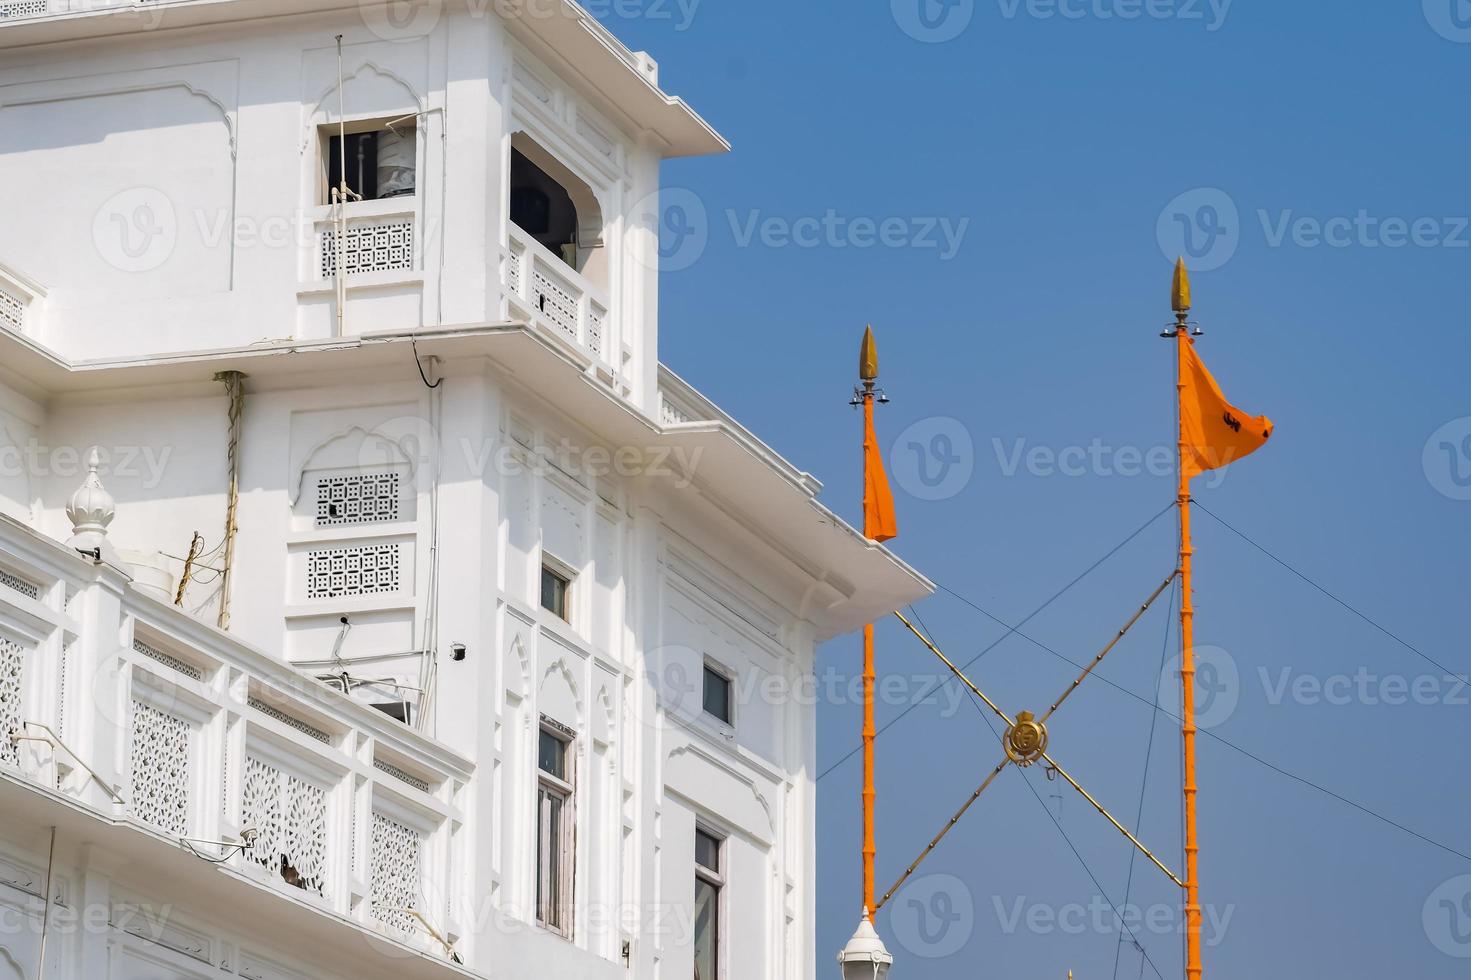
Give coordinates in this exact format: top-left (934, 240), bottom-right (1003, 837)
top-left (510, 132), bottom-right (608, 282)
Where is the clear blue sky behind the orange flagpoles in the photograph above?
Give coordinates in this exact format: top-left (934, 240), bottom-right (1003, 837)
top-left (594, 0), bottom-right (1471, 980)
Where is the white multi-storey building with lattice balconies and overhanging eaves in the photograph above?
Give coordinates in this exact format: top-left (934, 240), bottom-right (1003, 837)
top-left (0, 0), bottom-right (930, 980)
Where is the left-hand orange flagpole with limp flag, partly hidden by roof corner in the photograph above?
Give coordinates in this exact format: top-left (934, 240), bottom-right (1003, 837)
top-left (856, 327), bottom-right (899, 912)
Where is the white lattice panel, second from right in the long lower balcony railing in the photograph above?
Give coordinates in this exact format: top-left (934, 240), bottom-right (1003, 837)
top-left (241, 756), bottom-right (327, 895)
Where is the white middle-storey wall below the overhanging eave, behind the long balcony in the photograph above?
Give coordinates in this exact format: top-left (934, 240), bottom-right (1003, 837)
top-left (0, 354), bottom-right (813, 977)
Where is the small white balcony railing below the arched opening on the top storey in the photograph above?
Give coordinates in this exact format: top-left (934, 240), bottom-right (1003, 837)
top-left (506, 225), bottom-right (612, 363)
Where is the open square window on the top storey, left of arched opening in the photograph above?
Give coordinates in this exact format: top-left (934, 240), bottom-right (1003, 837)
top-left (319, 116), bottom-right (419, 205)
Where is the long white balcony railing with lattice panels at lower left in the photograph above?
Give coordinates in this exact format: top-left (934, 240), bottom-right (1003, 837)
top-left (0, 516), bottom-right (472, 958)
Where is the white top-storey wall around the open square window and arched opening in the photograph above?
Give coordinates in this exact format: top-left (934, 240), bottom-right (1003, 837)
top-left (0, 4), bottom-right (659, 411)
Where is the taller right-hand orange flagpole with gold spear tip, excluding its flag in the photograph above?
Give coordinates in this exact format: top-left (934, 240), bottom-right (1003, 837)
top-left (1171, 259), bottom-right (1202, 980)
